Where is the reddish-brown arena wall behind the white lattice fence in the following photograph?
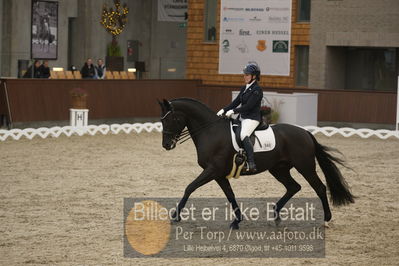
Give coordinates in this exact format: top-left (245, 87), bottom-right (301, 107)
top-left (0, 79), bottom-right (396, 124)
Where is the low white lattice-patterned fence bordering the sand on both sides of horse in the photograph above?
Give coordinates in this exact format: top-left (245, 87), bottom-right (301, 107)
top-left (0, 122), bottom-right (399, 141)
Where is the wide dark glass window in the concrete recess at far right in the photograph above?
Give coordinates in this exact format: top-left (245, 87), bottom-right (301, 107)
top-left (345, 47), bottom-right (398, 91)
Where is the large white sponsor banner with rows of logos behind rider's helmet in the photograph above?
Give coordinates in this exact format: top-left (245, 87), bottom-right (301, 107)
top-left (219, 0), bottom-right (291, 76)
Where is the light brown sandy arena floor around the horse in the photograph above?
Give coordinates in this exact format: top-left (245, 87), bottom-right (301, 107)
top-left (0, 133), bottom-right (399, 265)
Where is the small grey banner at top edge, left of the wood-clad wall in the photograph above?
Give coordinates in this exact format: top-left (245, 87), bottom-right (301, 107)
top-left (158, 0), bottom-right (188, 22)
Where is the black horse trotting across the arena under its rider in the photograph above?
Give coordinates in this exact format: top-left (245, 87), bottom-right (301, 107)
top-left (159, 98), bottom-right (354, 229)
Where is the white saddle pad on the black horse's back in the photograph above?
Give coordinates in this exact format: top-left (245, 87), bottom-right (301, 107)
top-left (230, 123), bottom-right (276, 152)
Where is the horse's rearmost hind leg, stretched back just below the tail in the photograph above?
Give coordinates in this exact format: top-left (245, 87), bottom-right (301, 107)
top-left (296, 163), bottom-right (331, 222)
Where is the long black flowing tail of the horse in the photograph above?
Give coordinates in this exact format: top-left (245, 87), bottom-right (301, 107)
top-left (309, 132), bottom-right (355, 206)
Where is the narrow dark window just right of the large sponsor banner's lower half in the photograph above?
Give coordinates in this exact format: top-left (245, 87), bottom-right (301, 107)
top-left (295, 45), bottom-right (309, 87)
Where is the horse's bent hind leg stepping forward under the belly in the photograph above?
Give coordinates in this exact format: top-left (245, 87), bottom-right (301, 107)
top-left (269, 167), bottom-right (301, 224)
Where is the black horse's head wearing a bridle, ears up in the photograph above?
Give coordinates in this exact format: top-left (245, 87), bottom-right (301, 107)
top-left (158, 99), bottom-right (186, 150)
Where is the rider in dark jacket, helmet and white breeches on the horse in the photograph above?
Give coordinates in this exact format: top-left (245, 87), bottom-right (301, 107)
top-left (217, 63), bottom-right (263, 172)
